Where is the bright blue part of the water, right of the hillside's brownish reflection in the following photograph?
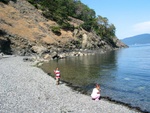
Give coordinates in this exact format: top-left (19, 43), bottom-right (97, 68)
top-left (99, 45), bottom-right (150, 112)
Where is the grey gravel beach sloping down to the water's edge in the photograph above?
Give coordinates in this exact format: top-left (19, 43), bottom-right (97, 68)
top-left (0, 56), bottom-right (139, 113)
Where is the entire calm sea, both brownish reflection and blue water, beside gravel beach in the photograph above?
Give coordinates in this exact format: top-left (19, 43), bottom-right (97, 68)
top-left (42, 44), bottom-right (150, 112)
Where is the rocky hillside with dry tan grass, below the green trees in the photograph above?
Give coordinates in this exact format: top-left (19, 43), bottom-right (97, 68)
top-left (0, 0), bottom-right (126, 58)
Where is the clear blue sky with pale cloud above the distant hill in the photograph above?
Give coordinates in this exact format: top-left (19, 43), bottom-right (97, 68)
top-left (80, 0), bottom-right (150, 39)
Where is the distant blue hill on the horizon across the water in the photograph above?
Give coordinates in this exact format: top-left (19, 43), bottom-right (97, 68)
top-left (121, 34), bottom-right (150, 45)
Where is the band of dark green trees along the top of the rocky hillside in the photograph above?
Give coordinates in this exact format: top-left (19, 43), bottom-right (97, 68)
top-left (28, 0), bottom-right (116, 39)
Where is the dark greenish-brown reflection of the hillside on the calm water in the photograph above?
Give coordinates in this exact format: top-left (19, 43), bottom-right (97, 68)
top-left (42, 51), bottom-right (116, 87)
